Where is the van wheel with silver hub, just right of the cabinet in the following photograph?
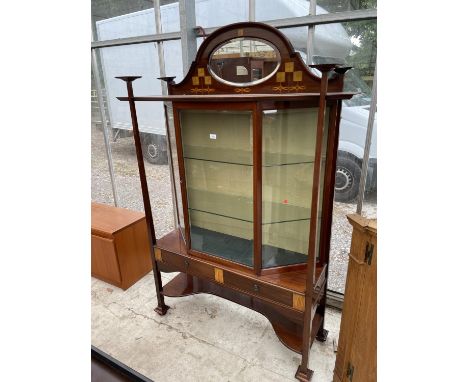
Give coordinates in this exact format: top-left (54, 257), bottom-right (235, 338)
top-left (335, 156), bottom-right (361, 203)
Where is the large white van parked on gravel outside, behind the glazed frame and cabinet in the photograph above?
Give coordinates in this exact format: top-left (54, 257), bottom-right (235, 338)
top-left (96, 0), bottom-right (377, 201)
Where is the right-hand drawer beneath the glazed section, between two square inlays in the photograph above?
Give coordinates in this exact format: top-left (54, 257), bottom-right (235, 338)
top-left (224, 272), bottom-right (292, 306)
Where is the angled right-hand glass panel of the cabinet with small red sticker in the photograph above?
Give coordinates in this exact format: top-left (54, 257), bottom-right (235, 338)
top-left (262, 108), bottom-right (328, 268)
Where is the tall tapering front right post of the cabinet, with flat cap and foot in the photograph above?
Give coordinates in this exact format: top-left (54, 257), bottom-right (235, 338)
top-left (296, 64), bottom-right (337, 382)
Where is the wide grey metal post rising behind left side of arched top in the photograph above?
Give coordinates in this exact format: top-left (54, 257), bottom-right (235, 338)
top-left (179, 0), bottom-right (197, 76)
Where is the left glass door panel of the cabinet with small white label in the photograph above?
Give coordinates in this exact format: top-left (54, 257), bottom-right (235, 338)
top-left (179, 110), bottom-right (253, 266)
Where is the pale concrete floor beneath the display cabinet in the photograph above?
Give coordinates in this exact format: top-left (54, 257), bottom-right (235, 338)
top-left (91, 273), bottom-right (341, 382)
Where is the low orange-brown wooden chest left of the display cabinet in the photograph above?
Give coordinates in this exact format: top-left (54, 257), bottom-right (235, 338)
top-left (91, 203), bottom-right (152, 290)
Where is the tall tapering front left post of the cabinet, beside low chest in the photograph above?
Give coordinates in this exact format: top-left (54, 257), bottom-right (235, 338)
top-left (116, 76), bottom-right (169, 316)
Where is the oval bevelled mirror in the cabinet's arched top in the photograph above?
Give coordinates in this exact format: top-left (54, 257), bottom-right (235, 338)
top-left (208, 37), bottom-right (281, 86)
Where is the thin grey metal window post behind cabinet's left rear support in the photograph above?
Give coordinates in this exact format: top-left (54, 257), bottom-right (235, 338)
top-left (154, 0), bottom-right (178, 229)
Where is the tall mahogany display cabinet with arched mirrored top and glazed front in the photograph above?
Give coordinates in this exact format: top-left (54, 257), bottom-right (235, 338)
top-left (118, 22), bottom-right (354, 381)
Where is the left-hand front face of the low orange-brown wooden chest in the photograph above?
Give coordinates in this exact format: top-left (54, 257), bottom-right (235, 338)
top-left (91, 235), bottom-right (122, 284)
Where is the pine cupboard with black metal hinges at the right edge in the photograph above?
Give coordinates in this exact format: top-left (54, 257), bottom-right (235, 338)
top-left (333, 214), bottom-right (377, 382)
